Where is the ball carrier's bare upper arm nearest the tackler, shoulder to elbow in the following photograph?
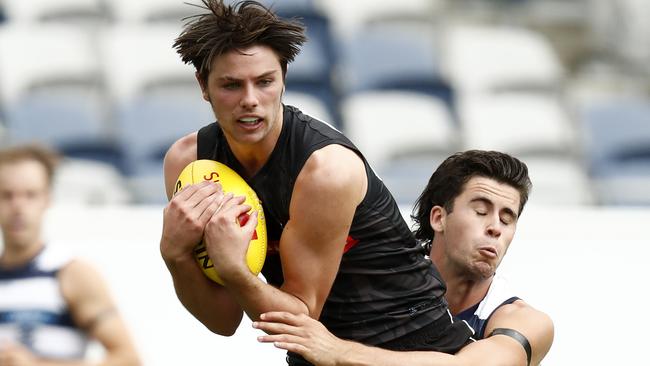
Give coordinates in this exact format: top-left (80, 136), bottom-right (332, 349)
top-left (280, 146), bottom-right (366, 317)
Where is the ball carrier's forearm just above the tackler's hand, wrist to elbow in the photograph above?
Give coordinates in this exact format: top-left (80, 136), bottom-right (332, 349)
top-left (222, 272), bottom-right (309, 320)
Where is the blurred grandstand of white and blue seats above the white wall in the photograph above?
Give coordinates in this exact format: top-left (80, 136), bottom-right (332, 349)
top-left (0, 0), bottom-right (650, 206)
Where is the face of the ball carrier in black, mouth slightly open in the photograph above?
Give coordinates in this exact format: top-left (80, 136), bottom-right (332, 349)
top-left (201, 46), bottom-right (284, 147)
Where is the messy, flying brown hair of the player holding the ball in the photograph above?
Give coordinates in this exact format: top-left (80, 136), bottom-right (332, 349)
top-left (173, 0), bottom-right (307, 82)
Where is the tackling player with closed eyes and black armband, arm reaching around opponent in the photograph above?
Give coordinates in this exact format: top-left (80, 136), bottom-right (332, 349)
top-left (254, 150), bottom-right (554, 366)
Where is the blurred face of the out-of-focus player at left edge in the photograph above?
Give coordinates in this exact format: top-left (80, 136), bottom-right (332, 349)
top-left (0, 160), bottom-right (50, 247)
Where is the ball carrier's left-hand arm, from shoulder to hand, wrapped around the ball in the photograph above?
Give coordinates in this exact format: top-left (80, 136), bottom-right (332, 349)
top-left (160, 133), bottom-right (243, 336)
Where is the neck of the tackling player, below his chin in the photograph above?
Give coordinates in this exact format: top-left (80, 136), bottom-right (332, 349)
top-left (443, 274), bottom-right (493, 315)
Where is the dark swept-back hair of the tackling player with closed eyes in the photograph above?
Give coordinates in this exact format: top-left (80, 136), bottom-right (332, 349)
top-left (411, 150), bottom-right (532, 252)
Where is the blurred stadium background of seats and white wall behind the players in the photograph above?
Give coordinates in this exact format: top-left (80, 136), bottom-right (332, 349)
top-left (0, 0), bottom-right (650, 366)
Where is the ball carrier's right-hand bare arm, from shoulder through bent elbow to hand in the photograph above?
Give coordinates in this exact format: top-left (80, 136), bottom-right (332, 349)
top-left (206, 145), bottom-right (367, 320)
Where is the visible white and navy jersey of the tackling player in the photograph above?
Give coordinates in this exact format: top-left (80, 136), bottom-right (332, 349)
top-left (456, 274), bottom-right (519, 339)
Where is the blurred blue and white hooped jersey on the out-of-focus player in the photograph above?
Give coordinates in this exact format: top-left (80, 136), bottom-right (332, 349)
top-left (0, 247), bottom-right (88, 360)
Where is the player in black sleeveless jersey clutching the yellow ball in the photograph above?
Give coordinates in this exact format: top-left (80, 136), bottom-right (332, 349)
top-left (160, 0), bottom-right (471, 365)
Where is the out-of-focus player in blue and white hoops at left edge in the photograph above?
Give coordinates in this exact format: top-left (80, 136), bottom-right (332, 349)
top-left (0, 146), bottom-right (140, 366)
